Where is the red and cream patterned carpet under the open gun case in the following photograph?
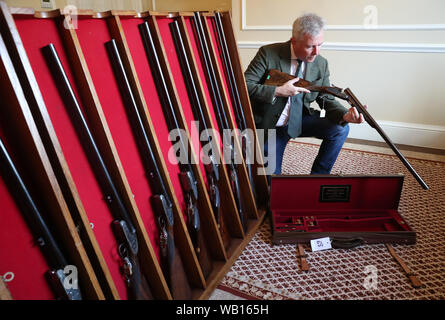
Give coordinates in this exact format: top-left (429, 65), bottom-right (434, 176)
top-left (218, 142), bottom-right (445, 300)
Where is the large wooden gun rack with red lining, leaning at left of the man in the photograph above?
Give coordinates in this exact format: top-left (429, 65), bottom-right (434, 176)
top-left (0, 2), bottom-right (268, 299)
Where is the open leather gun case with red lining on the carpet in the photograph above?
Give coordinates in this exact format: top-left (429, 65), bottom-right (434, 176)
top-left (270, 175), bottom-right (416, 248)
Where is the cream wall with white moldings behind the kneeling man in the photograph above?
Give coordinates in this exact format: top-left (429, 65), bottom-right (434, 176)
top-left (232, 0), bottom-right (445, 149)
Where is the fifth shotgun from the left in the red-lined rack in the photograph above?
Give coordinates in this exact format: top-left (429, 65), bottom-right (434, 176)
top-left (169, 20), bottom-right (230, 248)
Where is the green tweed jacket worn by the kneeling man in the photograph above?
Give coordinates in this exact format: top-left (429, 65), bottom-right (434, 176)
top-left (244, 41), bottom-right (347, 129)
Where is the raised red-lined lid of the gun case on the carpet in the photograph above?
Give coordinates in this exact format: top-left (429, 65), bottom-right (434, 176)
top-left (270, 175), bottom-right (404, 211)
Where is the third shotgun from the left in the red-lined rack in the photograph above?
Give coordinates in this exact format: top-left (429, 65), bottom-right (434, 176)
top-left (105, 39), bottom-right (191, 299)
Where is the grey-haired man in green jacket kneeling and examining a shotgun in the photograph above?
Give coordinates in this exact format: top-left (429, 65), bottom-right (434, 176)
top-left (245, 14), bottom-right (366, 174)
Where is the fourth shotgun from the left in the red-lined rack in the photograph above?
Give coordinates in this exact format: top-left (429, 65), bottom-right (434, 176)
top-left (139, 21), bottom-right (212, 277)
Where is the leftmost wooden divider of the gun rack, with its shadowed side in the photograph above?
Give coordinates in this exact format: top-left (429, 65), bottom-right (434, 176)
top-left (0, 27), bottom-right (104, 299)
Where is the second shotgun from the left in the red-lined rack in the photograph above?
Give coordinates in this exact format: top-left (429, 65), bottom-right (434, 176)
top-left (41, 43), bottom-right (153, 300)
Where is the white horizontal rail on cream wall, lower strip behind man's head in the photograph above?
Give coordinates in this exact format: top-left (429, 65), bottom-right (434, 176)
top-left (238, 41), bottom-right (445, 53)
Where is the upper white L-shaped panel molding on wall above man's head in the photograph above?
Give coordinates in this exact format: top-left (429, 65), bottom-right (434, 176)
top-left (241, 0), bottom-right (445, 31)
